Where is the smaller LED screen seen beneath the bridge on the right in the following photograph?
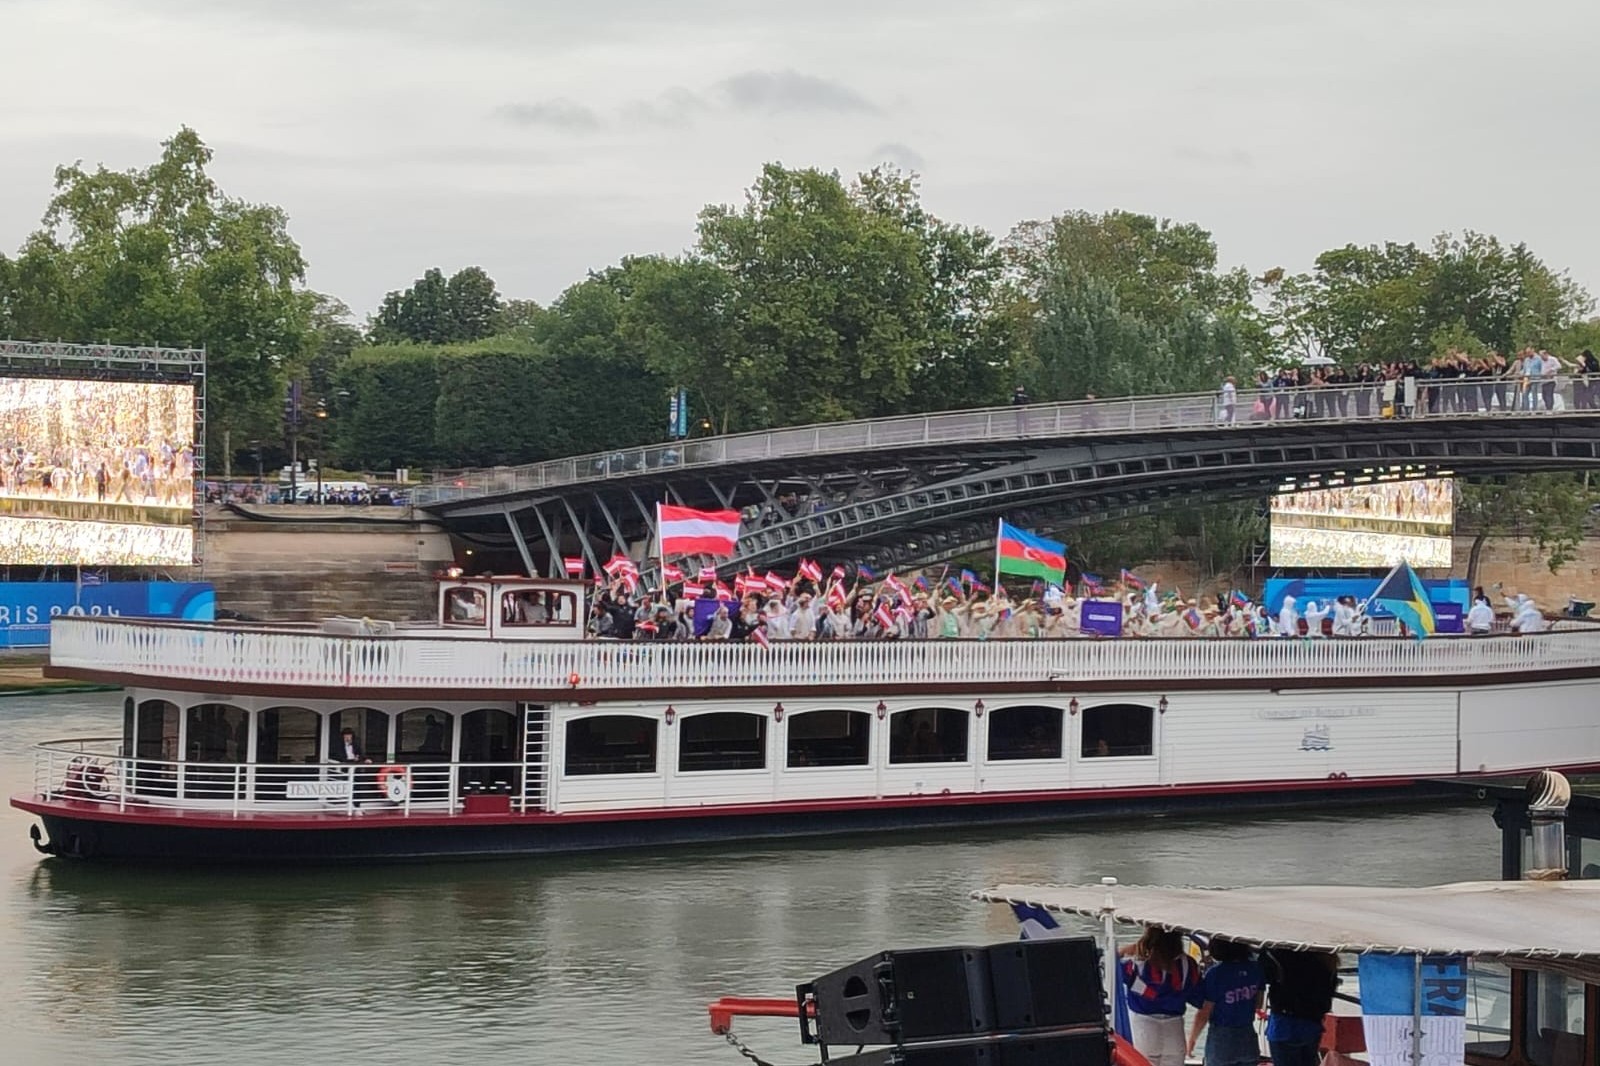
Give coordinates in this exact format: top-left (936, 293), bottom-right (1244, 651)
top-left (1269, 479), bottom-right (1456, 567)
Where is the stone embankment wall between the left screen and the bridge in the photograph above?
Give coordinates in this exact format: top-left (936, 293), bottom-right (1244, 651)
top-left (200, 507), bottom-right (454, 621)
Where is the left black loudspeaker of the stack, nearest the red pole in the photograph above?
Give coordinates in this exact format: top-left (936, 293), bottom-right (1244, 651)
top-left (795, 948), bottom-right (994, 1044)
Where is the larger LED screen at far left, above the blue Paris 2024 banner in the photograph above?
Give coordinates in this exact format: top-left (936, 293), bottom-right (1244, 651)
top-left (0, 378), bottom-right (195, 567)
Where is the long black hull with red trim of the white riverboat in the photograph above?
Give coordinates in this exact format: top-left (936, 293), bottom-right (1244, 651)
top-left (13, 779), bottom-right (1459, 866)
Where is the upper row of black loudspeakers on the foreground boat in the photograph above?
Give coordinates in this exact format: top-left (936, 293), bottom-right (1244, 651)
top-left (795, 936), bottom-right (1106, 1045)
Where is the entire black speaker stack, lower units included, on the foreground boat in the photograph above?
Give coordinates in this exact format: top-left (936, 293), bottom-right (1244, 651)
top-left (795, 936), bottom-right (1110, 1066)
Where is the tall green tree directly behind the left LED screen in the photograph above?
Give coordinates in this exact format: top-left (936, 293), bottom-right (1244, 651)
top-left (0, 126), bottom-right (312, 455)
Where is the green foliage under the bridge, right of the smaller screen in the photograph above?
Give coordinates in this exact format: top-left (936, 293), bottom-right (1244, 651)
top-left (1456, 474), bottom-right (1597, 587)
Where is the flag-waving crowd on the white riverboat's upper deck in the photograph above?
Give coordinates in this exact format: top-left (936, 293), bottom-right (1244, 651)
top-left (589, 559), bottom-right (1547, 645)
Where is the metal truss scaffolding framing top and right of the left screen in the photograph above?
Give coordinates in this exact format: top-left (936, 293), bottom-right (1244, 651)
top-left (0, 339), bottom-right (206, 567)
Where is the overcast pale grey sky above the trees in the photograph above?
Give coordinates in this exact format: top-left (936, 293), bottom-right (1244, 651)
top-left (0, 0), bottom-right (1600, 312)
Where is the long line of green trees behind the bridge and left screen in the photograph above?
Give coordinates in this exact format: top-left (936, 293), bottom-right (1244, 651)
top-left (0, 128), bottom-right (1600, 585)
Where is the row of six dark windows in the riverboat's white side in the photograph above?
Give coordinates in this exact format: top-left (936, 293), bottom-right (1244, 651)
top-left (565, 704), bottom-right (1155, 776)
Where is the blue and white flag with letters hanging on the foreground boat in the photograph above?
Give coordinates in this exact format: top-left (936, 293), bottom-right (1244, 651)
top-left (1357, 956), bottom-right (1467, 1066)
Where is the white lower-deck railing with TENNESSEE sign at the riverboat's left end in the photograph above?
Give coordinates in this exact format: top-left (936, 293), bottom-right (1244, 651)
top-left (34, 736), bottom-right (542, 816)
